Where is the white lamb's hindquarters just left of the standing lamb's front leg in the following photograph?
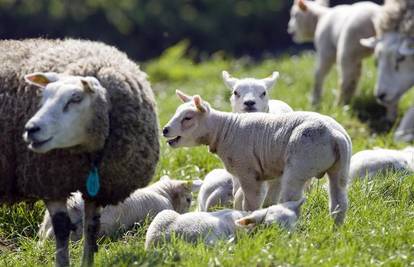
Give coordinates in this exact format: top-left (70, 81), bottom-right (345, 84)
top-left (197, 169), bottom-right (233, 211)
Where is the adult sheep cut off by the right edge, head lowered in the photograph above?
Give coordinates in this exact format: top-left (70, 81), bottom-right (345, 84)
top-left (360, 0), bottom-right (414, 119)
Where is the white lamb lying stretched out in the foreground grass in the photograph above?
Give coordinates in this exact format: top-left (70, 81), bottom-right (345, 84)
top-left (145, 199), bottom-right (304, 249)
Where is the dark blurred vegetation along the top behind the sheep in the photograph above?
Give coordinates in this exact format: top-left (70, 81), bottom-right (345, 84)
top-left (0, 0), bottom-right (382, 60)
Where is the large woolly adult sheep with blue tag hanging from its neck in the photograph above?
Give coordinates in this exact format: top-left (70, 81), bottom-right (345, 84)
top-left (0, 39), bottom-right (159, 266)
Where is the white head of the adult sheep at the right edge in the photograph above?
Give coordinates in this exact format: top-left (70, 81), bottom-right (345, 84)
top-left (361, 32), bottom-right (414, 119)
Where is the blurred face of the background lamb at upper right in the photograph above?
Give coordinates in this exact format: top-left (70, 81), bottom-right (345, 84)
top-left (287, 1), bottom-right (316, 43)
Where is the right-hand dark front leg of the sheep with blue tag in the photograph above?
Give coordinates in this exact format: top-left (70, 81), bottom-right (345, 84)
top-left (82, 201), bottom-right (101, 266)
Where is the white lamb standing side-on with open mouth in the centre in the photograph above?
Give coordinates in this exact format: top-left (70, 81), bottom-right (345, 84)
top-left (163, 91), bottom-right (352, 223)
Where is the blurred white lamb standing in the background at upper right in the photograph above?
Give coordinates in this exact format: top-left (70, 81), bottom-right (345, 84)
top-left (288, 0), bottom-right (380, 105)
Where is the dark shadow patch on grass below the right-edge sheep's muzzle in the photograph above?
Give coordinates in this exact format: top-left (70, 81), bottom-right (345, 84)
top-left (351, 95), bottom-right (393, 133)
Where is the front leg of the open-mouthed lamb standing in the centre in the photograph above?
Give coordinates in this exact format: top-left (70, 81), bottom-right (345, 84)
top-left (239, 175), bottom-right (262, 211)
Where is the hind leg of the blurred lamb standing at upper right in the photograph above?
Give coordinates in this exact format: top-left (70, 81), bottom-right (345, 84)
top-left (337, 53), bottom-right (362, 105)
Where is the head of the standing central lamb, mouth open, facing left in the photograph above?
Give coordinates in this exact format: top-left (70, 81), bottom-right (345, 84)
top-left (162, 90), bottom-right (210, 148)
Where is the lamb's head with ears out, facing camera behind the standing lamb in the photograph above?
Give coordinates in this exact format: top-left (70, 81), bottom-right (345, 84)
top-left (222, 71), bottom-right (279, 113)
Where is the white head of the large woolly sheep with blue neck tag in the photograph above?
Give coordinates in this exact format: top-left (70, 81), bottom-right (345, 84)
top-left (23, 73), bottom-right (109, 153)
